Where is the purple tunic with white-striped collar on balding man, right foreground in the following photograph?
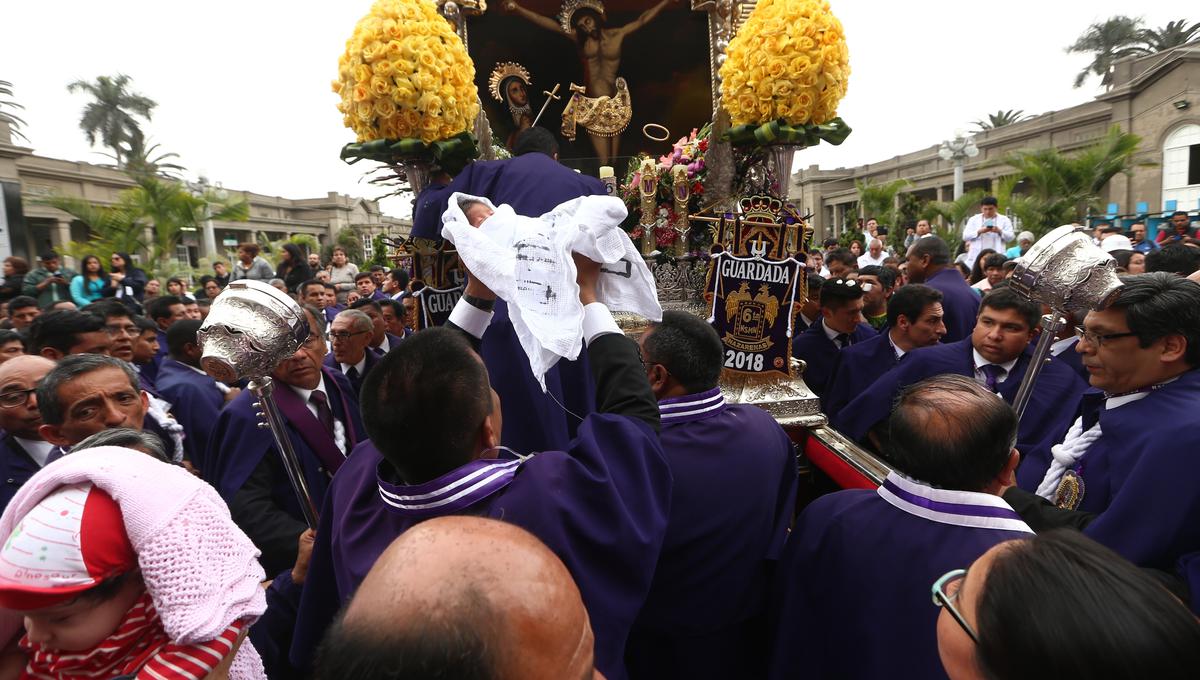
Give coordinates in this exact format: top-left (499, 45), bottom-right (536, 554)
top-left (769, 473), bottom-right (1032, 680)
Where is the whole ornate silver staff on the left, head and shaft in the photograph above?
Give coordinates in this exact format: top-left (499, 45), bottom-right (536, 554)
top-left (198, 279), bottom-right (317, 529)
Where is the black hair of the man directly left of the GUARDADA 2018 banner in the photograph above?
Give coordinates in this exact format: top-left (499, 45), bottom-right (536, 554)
top-left (642, 309), bottom-right (725, 395)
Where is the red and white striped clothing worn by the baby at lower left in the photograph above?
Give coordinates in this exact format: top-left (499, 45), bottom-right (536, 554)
top-left (20, 592), bottom-right (246, 680)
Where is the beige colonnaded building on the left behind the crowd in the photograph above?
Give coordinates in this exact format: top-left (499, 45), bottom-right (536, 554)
top-left (0, 120), bottom-right (412, 266)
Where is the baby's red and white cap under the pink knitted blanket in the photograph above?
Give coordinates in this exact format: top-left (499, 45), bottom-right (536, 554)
top-left (0, 482), bottom-right (138, 612)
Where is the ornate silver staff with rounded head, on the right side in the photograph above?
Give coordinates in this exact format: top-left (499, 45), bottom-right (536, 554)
top-left (1009, 224), bottom-right (1122, 420)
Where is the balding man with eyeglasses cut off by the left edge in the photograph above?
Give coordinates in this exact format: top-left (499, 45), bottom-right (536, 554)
top-left (0, 356), bottom-right (55, 512)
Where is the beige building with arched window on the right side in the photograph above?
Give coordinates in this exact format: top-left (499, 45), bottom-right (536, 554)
top-left (790, 41), bottom-right (1200, 240)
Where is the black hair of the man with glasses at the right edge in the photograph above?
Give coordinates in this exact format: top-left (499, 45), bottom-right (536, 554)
top-left (1104, 272), bottom-right (1200, 366)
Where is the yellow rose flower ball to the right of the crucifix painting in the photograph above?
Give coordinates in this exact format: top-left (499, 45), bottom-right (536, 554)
top-left (720, 0), bottom-right (850, 126)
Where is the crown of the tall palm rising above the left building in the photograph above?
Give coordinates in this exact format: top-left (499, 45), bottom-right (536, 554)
top-left (67, 74), bottom-right (158, 167)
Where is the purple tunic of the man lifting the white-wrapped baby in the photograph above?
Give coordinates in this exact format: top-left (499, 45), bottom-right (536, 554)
top-left (290, 414), bottom-right (671, 679)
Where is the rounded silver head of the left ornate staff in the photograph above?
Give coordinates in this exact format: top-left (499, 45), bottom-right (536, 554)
top-left (197, 279), bottom-right (310, 383)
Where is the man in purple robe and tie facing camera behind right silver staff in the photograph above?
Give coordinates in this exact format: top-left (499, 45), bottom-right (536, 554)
top-left (833, 287), bottom-right (1087, 488)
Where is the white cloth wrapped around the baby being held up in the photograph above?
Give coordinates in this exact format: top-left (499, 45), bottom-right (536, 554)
top-left (442, 192), bottom-right (662, 390)
